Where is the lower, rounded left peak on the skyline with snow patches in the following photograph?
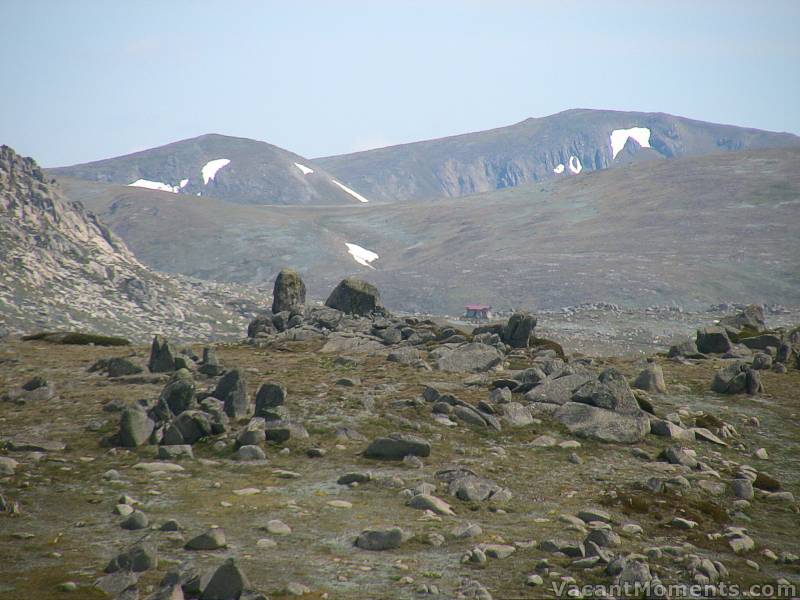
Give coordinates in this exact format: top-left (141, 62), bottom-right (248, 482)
top-left (52, 134), bottom-right (376, 204)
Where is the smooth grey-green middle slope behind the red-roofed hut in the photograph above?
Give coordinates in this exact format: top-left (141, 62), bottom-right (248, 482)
top-left (62, 148), bottom-right (800, 314)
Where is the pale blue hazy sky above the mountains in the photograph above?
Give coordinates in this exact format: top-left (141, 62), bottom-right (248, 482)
top-left (0, 0), bottom-right (800, 166)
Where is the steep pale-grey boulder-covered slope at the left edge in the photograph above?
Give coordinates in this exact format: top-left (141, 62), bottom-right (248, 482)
top-left (0, 146), bottom-right (268, 341)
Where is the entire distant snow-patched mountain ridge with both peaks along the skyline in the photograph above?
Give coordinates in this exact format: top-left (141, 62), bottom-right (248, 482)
top-left (49, 109), bottom-right (800, 205)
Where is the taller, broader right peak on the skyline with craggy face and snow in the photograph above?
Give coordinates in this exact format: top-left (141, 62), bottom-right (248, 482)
top-left (313, 109), bottom-right (800, 201)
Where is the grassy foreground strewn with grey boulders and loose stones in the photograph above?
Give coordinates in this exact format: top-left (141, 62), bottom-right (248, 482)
top-left (0, 286), bottom-right (800, 600)
